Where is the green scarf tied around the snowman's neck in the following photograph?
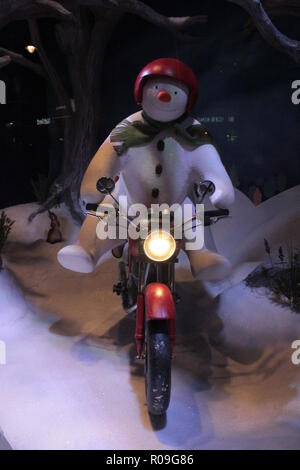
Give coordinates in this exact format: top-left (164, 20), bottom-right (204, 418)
top-left (110, 112), bottom-right (214, 156)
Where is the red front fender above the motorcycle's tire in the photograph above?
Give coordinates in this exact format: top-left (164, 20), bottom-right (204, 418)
top-left (145, 282), bottom-right (175, 321)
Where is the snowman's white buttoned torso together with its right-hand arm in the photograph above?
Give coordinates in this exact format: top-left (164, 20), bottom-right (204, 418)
top-left (111, 112), bottom-right (234, 208)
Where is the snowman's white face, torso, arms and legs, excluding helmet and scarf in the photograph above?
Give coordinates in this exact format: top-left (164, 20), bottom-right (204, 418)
top-left (58, 77), bottom-right (234, 279)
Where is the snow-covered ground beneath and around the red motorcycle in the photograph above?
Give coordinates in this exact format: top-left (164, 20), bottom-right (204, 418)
top-left (0, 187), bottom-right (300, 449)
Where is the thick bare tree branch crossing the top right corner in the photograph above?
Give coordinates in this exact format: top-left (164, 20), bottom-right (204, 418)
top-left (228, 0), bottom-right (300, 63)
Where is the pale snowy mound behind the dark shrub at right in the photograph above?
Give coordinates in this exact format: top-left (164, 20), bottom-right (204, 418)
top-left (212, 185), bottom-right (300, 265)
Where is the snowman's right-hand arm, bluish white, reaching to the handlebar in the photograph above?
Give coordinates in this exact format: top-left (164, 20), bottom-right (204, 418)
top-left (192, 144), bottom-right (234, 208)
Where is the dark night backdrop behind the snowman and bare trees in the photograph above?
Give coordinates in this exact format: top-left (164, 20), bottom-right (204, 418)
top-left (0, 0), bottom-right (300, 207)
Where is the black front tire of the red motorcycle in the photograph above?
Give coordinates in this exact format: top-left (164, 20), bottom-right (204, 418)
top-left (145, 320), bottom-right (171, 415)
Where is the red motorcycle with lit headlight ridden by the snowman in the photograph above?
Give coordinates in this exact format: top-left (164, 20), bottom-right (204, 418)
top-left (86, 177), bottom-right (229, 415)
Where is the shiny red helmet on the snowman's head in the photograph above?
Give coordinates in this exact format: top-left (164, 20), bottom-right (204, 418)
top-left (134, 59), bottom-right (198, 111)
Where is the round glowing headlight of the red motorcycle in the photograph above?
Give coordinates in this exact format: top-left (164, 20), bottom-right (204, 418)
top-left (144, 230), bottom-right (176, 261)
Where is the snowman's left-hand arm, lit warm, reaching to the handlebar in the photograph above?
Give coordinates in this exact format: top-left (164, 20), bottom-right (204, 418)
top-left (80, 137), bottom-right (120, 204)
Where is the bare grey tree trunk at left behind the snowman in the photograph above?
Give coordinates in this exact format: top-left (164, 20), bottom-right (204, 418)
top-left (57, 6), bottom-right (121, 222)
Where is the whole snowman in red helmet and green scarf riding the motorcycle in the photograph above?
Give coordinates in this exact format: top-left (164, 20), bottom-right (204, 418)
top-left (58, 58), bottom-right (234, 281)
